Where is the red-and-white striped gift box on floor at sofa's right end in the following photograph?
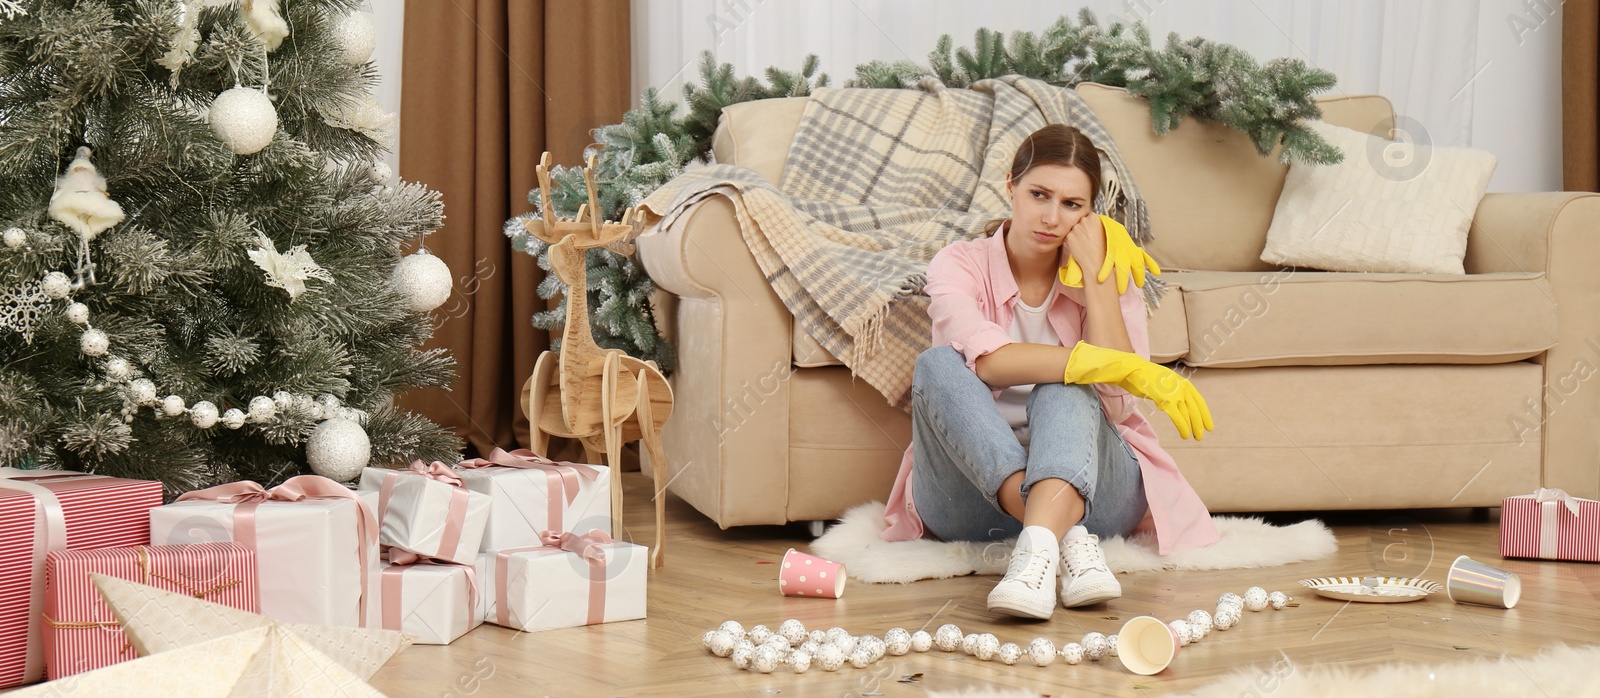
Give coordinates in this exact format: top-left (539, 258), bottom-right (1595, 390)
top-left (1501, 487), bottom-right (1600, 562)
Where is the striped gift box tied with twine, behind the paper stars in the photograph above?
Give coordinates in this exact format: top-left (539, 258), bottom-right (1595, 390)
top-left (43, 543), bottom-right (261, 679)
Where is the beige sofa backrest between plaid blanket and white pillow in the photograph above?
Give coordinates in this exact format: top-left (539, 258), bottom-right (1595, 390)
top-left (1077, 83), bottom-right (1394, 271)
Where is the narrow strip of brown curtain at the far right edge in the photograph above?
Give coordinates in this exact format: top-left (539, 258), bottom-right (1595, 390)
top-left (1562, 0), bottom-right (1600, 192)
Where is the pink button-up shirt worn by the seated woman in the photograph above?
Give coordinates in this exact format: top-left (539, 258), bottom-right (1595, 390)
top-left (882, 223), bottom-right (1219, 556)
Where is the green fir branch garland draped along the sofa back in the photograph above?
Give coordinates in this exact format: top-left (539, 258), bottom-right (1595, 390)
top-left (506, 8), bottom-right (1344, 371)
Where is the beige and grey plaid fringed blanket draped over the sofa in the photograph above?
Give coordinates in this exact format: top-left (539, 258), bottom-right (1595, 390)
top-left (640, 75), bottom-right (1160, 410)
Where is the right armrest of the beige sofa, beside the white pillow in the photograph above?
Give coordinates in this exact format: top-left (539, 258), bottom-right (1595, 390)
top-left (1466, 192), bottom-right (1600, 498)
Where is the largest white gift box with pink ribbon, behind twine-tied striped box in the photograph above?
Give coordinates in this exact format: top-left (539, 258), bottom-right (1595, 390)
top-left (150, 499), bottom-right (378, 628)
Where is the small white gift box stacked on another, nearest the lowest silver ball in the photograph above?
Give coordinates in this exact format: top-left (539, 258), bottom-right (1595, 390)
top-left (358, 464), bottom-right (494, 565)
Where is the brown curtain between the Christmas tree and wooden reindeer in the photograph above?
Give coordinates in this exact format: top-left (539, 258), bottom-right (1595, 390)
top-left (400, 0), bottom-right (632, 453)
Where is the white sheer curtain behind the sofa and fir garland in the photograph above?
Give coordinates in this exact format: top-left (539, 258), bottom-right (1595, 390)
top-left (634, 0), bottom-right (1560, 191)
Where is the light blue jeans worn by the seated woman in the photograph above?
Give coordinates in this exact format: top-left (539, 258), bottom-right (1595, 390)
top-left (910, 346), bottom-right (1147, 541)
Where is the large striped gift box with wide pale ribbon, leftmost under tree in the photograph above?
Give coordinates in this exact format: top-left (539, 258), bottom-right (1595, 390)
top-left (0, 467), bottom-right (162, 687)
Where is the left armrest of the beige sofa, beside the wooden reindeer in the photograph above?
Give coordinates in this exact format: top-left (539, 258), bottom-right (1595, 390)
top-left (635, 197), bottom-right (794, 528)
